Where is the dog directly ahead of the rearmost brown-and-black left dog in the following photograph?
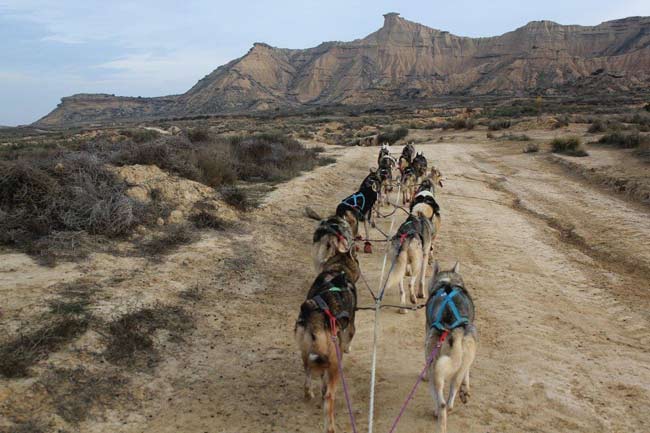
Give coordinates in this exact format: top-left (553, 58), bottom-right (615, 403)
top-left (312, 215), bottom-right (354, 272)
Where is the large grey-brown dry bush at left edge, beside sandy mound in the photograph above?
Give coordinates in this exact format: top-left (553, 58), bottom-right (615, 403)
top-left (0, 153), bottom-right (144, 259)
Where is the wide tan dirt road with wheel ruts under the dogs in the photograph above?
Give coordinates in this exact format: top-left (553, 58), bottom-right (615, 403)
top-left (62, 143), bottom-right (650, 433)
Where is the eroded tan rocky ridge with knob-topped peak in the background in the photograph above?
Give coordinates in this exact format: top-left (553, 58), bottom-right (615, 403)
top-left (37, 13), bottom-right (650, 126)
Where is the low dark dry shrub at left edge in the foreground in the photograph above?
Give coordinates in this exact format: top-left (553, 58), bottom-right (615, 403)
top-left (0, 315), bottom-right (89, 378)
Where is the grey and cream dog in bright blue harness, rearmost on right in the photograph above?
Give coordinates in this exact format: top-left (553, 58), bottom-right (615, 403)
top-left (424, 261), bottom-right (478, 433)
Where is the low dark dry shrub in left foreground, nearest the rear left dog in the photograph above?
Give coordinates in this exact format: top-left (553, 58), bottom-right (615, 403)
top-left (104, 304), bottom-right (193, 368)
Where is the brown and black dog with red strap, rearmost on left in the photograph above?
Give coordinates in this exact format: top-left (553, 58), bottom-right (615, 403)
top-left (295, 250), bottom-right (359, 433)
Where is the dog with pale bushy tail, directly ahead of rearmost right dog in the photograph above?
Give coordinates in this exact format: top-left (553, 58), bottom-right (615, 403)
top-left (385, 215), bottom-right (434, 313)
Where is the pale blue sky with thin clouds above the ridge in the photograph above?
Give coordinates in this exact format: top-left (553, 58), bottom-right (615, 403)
top-left (0, 0), bottom-right (650, 126)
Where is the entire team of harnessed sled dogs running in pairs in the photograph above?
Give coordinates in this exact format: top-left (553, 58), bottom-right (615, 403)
top-left (295, 144), bottom-right (477, 433)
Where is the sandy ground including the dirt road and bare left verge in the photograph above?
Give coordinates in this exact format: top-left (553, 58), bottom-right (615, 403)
top-left (0, 119), bottom-right (650, 433)
